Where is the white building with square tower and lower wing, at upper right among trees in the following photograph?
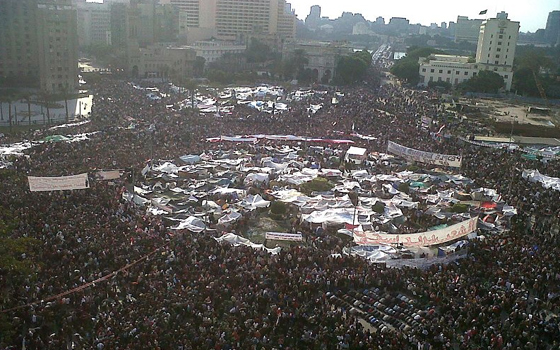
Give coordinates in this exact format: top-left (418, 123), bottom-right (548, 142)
top-left (419, 12), bottom-right (519, 90)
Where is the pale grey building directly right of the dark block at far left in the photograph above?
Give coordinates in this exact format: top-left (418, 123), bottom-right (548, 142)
top-left (77, 0), bottom-right (111, 47)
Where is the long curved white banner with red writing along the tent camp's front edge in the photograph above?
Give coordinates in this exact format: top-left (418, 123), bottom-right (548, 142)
top-left (354, 217), bottom-right (478, 247)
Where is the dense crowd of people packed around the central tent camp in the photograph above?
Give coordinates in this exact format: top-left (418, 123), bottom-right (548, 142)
top-left (0, 63), bottom-right (560, 350)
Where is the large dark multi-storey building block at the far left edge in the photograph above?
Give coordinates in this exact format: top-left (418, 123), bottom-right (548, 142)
top-left (0, 0), bottom-right (78, 93)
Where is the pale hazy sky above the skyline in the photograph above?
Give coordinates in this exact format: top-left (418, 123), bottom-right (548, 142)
top-left (287, 0), bottom-right (560, 32)
